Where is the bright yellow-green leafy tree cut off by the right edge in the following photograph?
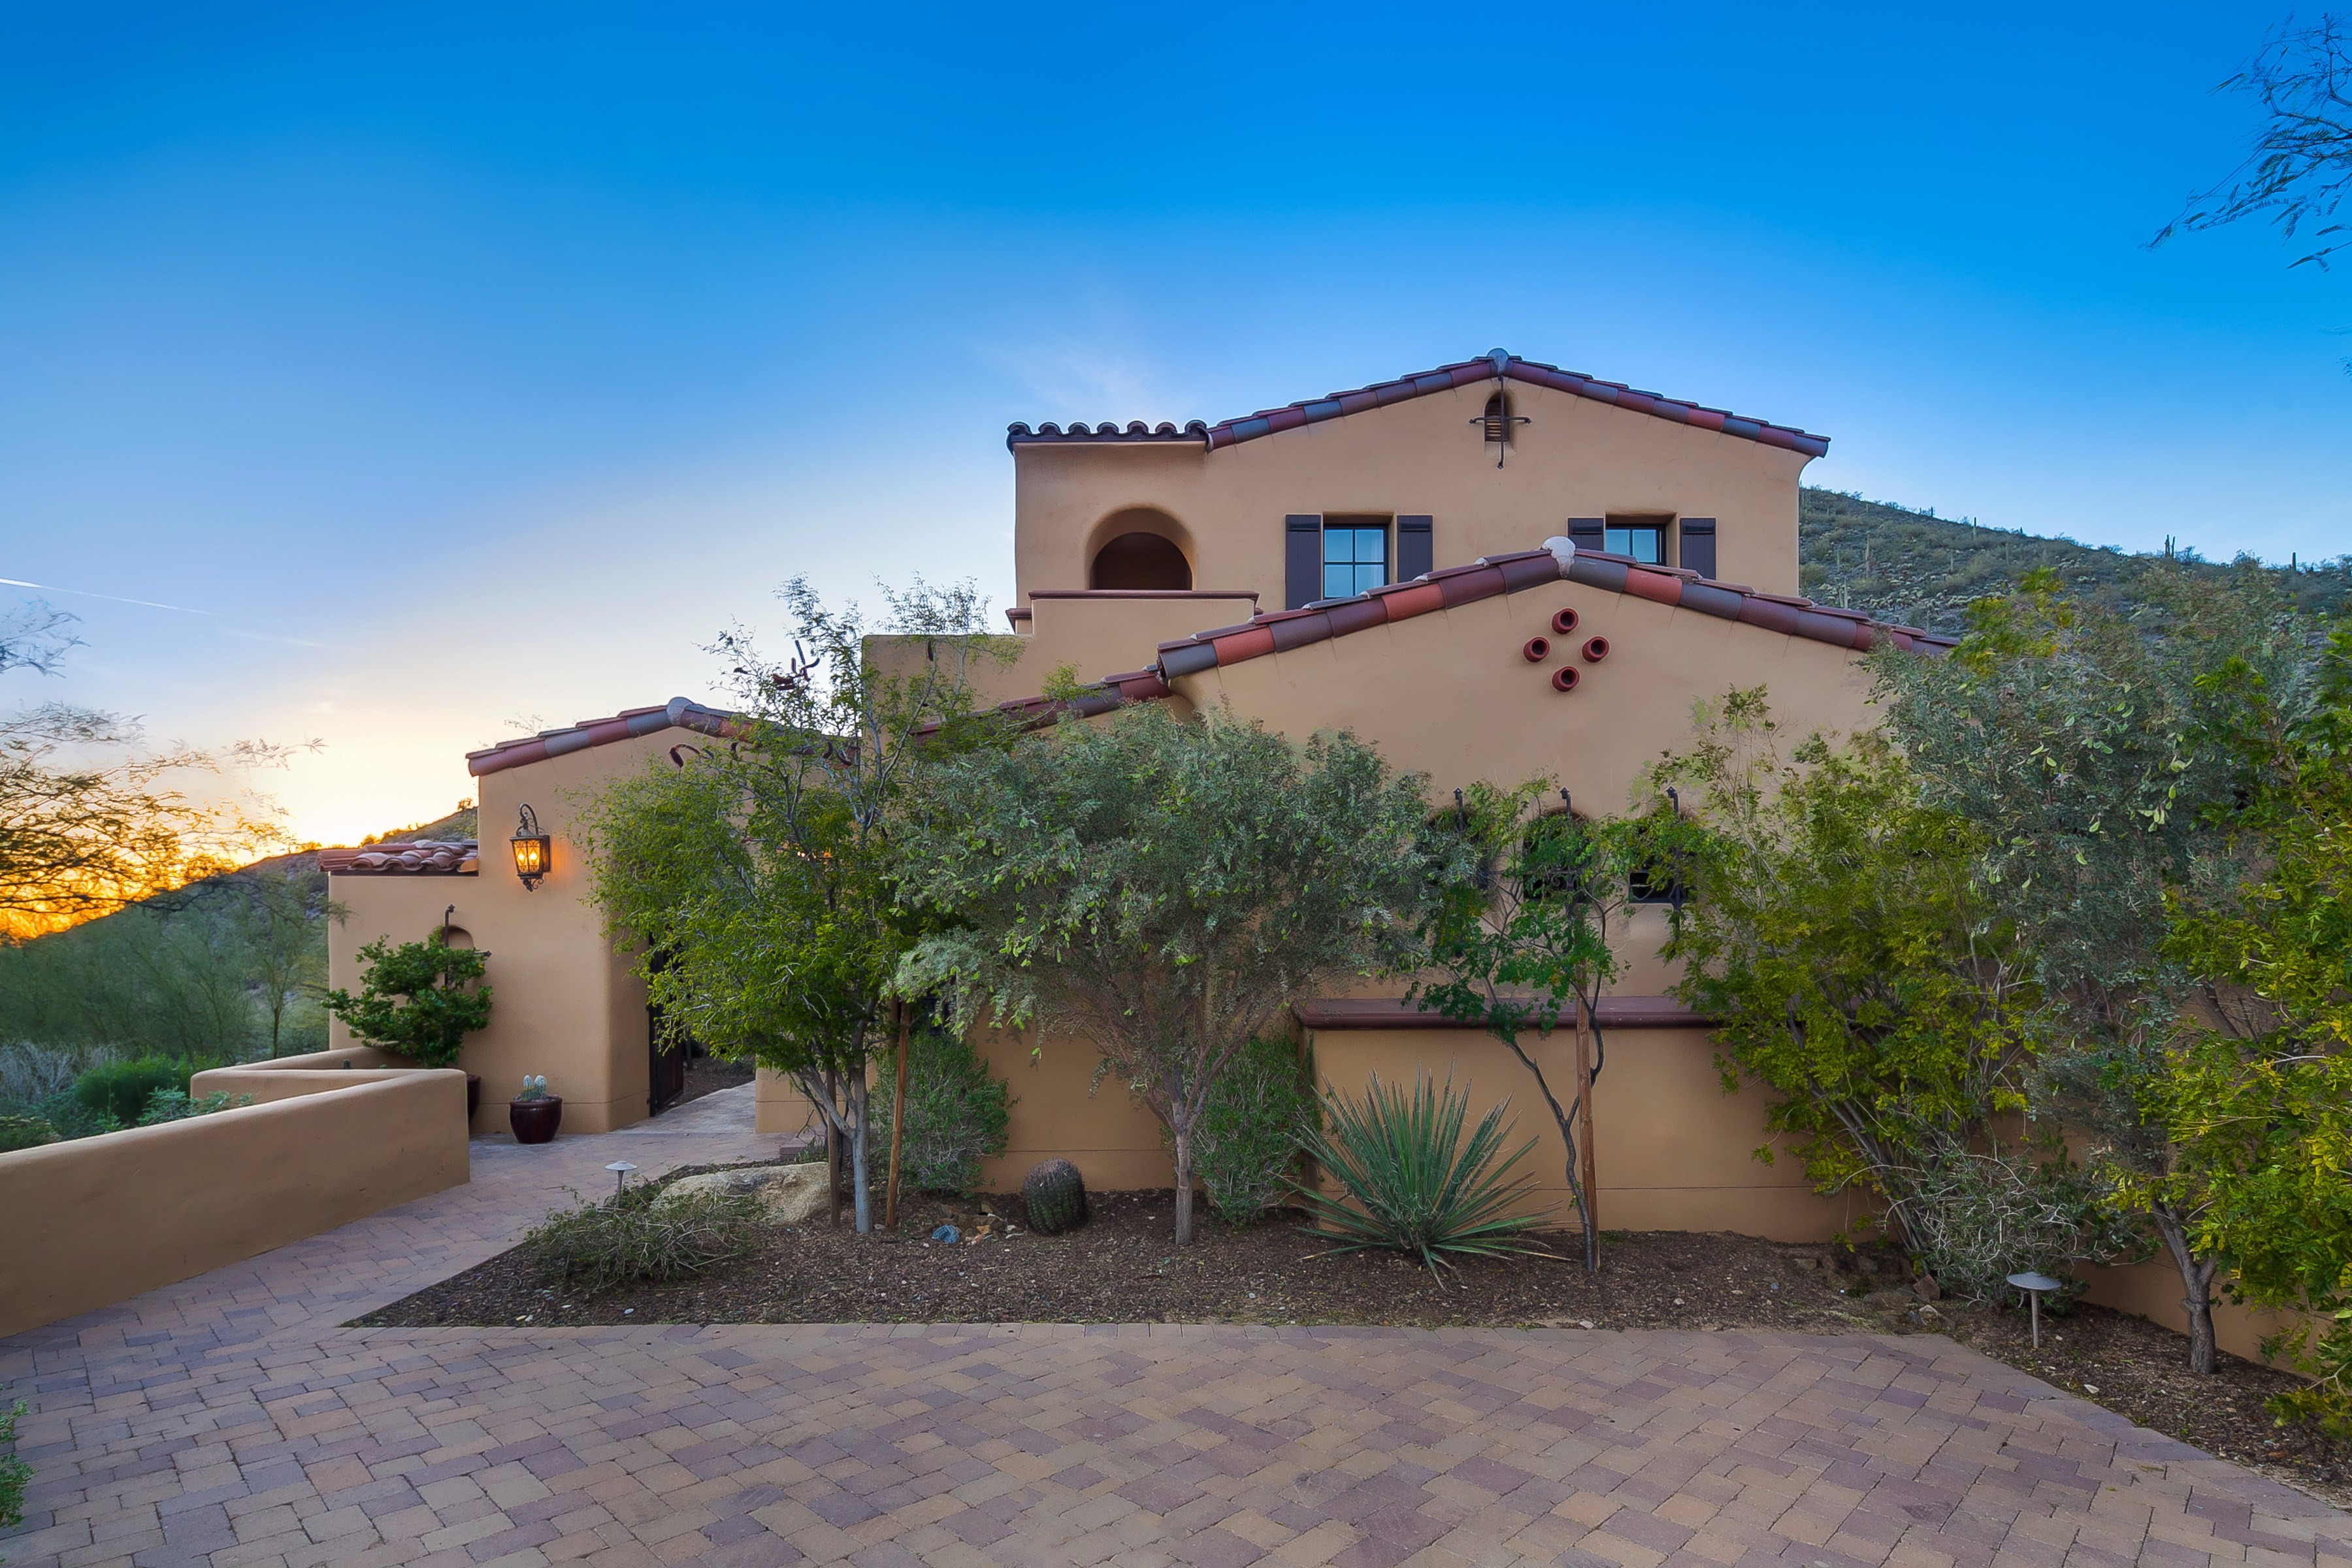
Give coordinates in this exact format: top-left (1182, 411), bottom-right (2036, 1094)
top-left (2136, 621), bottom-right (2352, 1437)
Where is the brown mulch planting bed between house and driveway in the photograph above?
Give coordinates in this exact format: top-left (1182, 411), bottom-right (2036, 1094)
top-left (357, 1166), bottom-right (2352, 1502)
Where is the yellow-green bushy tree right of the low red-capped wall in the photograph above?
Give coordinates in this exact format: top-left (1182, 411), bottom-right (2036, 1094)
top-left (1656, 689), bottom-right (2046, 1265)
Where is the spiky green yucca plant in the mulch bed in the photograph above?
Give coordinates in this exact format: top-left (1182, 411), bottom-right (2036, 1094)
top-left (1294, 1072), bottom-right (1545, 1279)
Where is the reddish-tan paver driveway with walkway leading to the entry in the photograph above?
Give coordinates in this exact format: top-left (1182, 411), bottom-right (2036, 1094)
top-left (0, 1091), bottom-right (2352, 1568)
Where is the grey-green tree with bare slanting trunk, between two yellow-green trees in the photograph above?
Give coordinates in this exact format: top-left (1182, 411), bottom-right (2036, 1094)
top-left (1877, 571), bottom-right (2310, 1371)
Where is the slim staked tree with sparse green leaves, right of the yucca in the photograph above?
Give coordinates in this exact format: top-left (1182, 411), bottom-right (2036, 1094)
top-left (1409, 778), bottom-right (1691, 1272)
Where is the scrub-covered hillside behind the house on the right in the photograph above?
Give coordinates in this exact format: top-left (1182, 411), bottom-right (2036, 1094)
top-left (1797, 489), bottom-right (2352, 632)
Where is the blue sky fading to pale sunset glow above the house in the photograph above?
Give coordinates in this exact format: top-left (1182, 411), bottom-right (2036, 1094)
top-left (0, 5), bottom-right (2352, 841)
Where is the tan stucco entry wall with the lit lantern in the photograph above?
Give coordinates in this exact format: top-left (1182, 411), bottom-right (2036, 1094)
top-left (327, 728), bottom-right (687, 1133)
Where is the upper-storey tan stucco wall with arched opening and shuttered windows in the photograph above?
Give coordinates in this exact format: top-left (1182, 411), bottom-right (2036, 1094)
top-left (1014, 381), bottom-right (1806, 620)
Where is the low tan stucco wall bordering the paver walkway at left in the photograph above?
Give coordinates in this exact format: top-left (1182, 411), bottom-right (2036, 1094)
top-left (0, 1051), bottom-right (468, 1335)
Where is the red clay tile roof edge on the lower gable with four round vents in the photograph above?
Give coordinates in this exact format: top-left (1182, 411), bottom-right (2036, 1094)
top-left (1147, 550), bottom-right (1955, 681)
